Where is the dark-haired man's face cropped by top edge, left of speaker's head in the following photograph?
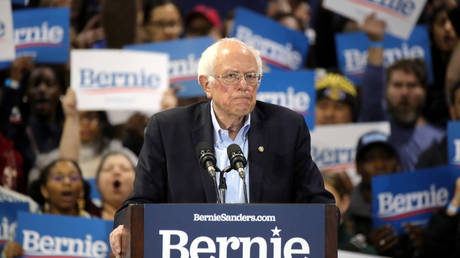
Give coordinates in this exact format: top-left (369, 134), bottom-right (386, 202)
top-left (144, 0), bottom-right (184, 42)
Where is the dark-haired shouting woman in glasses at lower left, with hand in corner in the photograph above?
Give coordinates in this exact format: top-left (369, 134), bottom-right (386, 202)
top-left (2, 159), bottom-right (91, 258)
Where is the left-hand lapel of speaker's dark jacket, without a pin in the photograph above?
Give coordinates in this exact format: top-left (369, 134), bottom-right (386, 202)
top-left (192, 101), bottom-right (217, 203)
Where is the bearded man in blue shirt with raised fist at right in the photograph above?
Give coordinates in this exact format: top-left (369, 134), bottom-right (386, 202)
top-left (359, 14), bottom-right (445, 171)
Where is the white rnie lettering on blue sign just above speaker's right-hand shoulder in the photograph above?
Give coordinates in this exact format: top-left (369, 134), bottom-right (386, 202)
top-left (257, 87), bottom-right (311, 113)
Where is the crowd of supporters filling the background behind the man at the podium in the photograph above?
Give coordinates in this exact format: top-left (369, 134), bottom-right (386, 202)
top-left (0, 0), bottom-right (460, 257)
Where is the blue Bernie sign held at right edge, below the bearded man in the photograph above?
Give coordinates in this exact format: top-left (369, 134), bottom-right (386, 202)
top-left (372, 166), bottom-right (460, 233)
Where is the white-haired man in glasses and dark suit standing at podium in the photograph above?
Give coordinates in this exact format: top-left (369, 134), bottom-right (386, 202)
top-left (110, 38), bottom-right (335, 257)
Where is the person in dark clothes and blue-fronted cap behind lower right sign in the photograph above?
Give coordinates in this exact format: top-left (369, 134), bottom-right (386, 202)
top-left (344, 131), bottom-right (421, 258)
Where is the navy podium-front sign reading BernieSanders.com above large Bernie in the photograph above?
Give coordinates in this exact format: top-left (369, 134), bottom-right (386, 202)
top-left (144, 204), bottom-right (325, 258)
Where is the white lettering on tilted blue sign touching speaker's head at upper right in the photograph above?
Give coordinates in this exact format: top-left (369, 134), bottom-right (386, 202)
top-left (236, 25), bottom-right (302, 70)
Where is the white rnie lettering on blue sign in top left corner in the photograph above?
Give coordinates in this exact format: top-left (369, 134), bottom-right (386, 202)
top-left (14, 22), bottom-right (64, 45)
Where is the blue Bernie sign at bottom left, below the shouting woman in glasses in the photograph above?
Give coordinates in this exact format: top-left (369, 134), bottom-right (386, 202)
top-left (16, 212), bottom-right (113, 258)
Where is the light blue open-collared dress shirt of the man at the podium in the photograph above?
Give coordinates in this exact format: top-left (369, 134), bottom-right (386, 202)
top-left (210, 101), bottom-right (251, 203)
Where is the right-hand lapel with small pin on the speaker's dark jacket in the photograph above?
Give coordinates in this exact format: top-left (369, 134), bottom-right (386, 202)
top-left (248, 105), bottom-right (270, 203)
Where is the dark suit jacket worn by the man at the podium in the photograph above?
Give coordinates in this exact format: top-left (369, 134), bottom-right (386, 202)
top-left (113, 101), bottom-right (335, 224)
